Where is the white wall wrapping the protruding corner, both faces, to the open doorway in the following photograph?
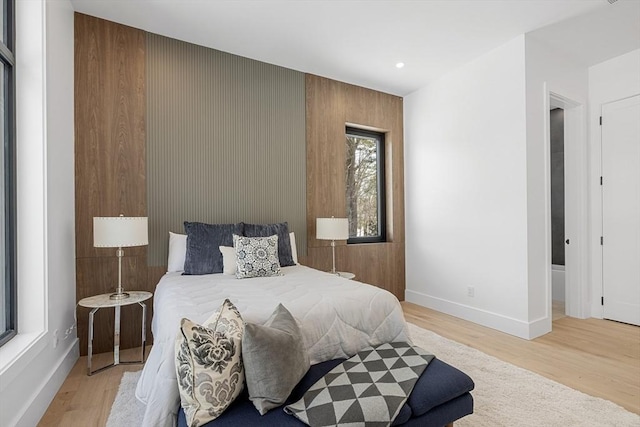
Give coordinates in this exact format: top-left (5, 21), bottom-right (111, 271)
top-left (404, 35), bottom-right (589, 339)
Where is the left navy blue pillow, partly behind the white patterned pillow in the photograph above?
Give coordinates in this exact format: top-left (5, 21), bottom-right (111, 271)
top-left (183, 221), bottom-right (243, 275)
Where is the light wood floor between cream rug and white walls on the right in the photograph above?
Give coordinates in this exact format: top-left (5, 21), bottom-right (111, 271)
top-left (402, 302), bottom-right (640, 419)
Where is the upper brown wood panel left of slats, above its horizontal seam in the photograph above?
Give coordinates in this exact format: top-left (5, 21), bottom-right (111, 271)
top-left (75, 13), bottom-right (146, 258)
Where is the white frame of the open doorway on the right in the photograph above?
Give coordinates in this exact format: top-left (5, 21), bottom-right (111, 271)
top-left (544, 88), bottom-right (590, 319)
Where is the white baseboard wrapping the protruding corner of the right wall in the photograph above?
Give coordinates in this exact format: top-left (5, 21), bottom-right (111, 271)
top-left (405, 289), bottom-right (551, 340)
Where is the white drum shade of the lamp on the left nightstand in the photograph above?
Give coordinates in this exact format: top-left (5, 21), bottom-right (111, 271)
top-left (93, 216), bottom-right (149, 248)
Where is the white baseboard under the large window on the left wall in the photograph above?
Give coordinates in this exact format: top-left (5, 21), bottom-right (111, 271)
top-left (16, 338), bottom-right (80, 427)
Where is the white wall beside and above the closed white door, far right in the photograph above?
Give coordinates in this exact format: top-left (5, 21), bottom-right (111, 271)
top-left (588, 49), bottom-right (640, 318)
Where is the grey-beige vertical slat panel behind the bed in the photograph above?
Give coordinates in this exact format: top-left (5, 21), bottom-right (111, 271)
top-left (146, 33), bottom-right (306, 265)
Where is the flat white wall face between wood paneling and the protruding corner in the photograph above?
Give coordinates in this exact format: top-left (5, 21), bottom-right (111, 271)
top-left (404, 35), bottom-right (529, 337)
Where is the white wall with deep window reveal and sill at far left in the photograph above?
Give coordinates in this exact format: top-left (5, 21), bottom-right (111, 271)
top-left (0, 0), bottom-right (78, 426)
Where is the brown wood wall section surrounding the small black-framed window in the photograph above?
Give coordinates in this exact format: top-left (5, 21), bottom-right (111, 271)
top-left (304, 75), bottom-right (405, 300)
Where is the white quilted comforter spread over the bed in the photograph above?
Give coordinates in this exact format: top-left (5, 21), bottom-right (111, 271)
top-left (136, 265), bottom-right (409, 427)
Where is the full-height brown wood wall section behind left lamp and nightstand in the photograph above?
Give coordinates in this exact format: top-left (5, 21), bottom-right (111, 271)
top-left (74, 13), bottom-right (155, 354)
